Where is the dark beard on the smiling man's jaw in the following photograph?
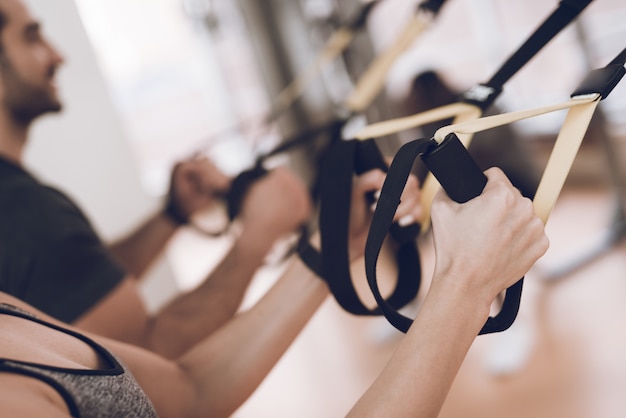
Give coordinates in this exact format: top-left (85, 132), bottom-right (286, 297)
top-left (0, 60), bottom-right (62, 125)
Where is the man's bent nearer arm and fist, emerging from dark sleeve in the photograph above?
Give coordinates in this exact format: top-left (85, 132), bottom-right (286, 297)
top-left (74, 168), bottom-right (311, 357)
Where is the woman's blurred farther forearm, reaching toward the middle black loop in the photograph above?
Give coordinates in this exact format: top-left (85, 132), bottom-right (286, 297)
top-left (173, 259), bottom-right (329, 417)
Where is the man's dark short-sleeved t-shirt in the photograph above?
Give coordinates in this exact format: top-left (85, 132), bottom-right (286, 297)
top-left (0, 158), bottom-right (125, 322)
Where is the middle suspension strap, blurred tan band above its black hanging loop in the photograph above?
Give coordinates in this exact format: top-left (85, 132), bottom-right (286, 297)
top-left (298, 0), bottom-right (444, 315)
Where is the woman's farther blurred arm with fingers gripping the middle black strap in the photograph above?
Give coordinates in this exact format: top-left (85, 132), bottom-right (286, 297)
top-left (112, 170), bottom-right (420, 417)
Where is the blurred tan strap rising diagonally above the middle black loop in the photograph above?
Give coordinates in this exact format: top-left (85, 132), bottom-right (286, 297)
top-left (344, 10), bottom-right (432, 113)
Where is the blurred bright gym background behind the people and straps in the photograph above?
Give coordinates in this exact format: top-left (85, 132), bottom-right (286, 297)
top-left (26, 0), bottom-right (626, 418)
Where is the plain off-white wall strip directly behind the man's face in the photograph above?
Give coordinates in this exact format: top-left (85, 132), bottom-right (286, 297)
top-left (21, 0), bottom-right (173, 306)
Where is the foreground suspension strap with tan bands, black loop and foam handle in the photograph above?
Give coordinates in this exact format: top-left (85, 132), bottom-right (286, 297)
top-left (365, 50), bottom-right (626, 334)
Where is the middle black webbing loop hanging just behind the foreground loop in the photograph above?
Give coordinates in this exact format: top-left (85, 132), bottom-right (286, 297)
top-left (300, 140), bottom-right (421, 315)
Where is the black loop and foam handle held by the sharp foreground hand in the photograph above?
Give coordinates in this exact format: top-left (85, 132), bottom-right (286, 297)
top-left (365, 134), bottom-right (523, 334)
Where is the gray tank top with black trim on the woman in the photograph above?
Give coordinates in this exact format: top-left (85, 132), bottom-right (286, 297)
top-left (0, 303), bottom-right (157, 418)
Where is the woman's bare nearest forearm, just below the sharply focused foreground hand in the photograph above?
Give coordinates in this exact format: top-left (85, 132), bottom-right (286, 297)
top-left (348, 274), bottom-right (489, 418)
